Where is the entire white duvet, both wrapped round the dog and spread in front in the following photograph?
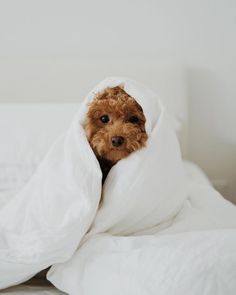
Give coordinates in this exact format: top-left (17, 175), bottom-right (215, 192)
top-left (0, 78), bottom-right (236, 295)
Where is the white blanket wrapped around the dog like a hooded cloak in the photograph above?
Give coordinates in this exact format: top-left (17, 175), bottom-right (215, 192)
top-left (0, 78), bottom-right (186, 287)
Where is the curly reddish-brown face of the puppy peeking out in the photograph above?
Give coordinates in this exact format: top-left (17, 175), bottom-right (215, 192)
top-left (85, 87), bottom-right (147, 163)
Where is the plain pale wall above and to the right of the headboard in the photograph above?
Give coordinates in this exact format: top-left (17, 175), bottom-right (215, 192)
top-left (0, 0), bottom-right (236, 201)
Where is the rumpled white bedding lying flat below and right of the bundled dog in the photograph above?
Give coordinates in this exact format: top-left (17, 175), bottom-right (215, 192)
top-left (49, 163), bottom-right (236, 295)
